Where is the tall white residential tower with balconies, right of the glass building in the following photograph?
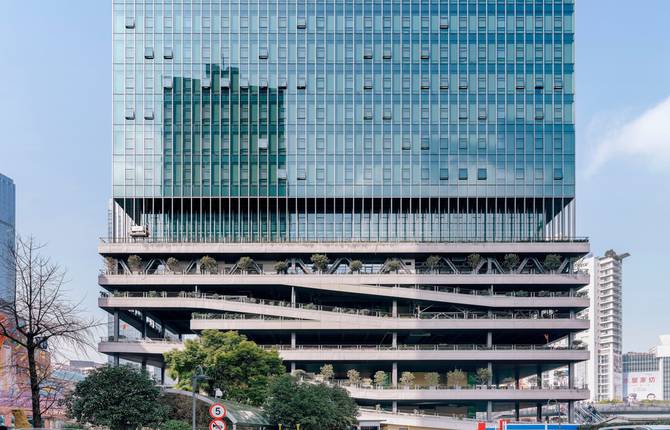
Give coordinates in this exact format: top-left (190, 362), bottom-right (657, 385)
top-left (575, 250), bottom-right (629, 401)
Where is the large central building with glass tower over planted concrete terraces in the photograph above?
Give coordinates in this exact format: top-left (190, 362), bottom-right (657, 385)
top-left (99, 0), bottom-right (589, 422)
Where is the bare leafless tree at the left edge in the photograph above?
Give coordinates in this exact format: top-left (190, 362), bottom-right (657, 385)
top-left (0, 237), bottom-right (99, 428)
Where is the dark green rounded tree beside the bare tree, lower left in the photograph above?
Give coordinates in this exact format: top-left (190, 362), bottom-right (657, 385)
top-left (66, 366), bottom-right (168, 430)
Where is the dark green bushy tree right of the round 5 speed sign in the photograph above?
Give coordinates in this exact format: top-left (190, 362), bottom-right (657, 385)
top-left (264, 375), bottom-right (358, 430)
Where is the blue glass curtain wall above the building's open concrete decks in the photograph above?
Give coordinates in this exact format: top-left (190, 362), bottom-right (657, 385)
top-left (110, 0), bottom-right (575, 241)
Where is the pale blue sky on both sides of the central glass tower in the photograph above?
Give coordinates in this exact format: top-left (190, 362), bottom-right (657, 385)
top-left (0, 0), bottom-right (670, 351)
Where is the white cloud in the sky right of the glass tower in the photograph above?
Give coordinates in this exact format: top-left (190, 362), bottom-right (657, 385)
top-left (586, 97), bottom-right (670, 175)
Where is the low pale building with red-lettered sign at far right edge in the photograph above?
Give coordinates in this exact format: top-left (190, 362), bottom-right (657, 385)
top-left (623, 334), bottom-right (670, 402)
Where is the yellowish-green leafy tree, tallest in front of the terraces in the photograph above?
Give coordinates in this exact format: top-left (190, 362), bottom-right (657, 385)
top-left (165, 330), bottom-right (286, 406)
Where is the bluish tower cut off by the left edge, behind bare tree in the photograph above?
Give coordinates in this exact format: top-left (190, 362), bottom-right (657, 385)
top-left (0, 173), bottom-right (16, 301)
